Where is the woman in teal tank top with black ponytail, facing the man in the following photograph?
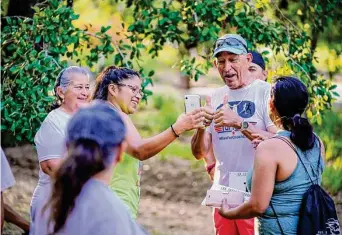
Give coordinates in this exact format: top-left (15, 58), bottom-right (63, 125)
top-left (220, 77), bottom-right (324, 235)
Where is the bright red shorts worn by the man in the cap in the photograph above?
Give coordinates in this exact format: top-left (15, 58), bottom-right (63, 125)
top-left (214, 209), bottom-right (254, 235)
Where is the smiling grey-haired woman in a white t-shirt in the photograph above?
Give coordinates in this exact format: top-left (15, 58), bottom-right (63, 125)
top-left (31, 66), bottom-right (90, 218)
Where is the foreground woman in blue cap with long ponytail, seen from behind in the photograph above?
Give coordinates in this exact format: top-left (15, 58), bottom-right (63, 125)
top-left (31, 103), bottom-right (146, 235)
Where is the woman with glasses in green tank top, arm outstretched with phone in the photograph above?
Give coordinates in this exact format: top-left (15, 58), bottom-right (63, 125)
top-left (92, 66), bottom-right (212, 218)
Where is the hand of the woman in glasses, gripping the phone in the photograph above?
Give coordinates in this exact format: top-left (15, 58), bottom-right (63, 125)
top-left (173, 108), bottom-right (205, 135)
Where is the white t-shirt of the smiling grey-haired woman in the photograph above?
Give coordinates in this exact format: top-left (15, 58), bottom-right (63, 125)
top-left (31, 108), bottom-right (71, 207)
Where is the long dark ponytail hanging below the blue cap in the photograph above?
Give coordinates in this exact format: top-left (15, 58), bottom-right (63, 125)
top-left (44, 139), bottom-right (114, 234)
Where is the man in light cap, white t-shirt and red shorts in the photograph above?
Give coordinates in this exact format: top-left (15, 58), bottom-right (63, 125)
top-left (191, 34), bottom-right (276, 235)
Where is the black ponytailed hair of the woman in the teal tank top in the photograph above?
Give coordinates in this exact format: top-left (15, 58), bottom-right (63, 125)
top-left (271, 77), bottom-right (316, 151)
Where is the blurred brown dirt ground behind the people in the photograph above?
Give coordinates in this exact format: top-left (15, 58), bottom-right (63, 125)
top-left (3, 145), bottom-right (342, 235)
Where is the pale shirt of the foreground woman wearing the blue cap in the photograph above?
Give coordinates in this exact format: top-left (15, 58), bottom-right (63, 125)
top-left (31, 179), bottom-right (146, 235)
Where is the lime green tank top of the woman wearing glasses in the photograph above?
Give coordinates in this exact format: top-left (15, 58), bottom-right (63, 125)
top-left (109, 153), bottom-right (142, 219)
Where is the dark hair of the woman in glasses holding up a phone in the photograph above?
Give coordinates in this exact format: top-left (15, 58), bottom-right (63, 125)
top-left (91, 65), bottom-right (140, 100)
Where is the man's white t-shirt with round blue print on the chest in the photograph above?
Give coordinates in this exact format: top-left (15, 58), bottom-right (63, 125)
top-left (207, 79), bottom-right (274, 186)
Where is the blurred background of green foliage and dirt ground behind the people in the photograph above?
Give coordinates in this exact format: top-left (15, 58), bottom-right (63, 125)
top-left (1, 0), bottom-right (342, 235)
